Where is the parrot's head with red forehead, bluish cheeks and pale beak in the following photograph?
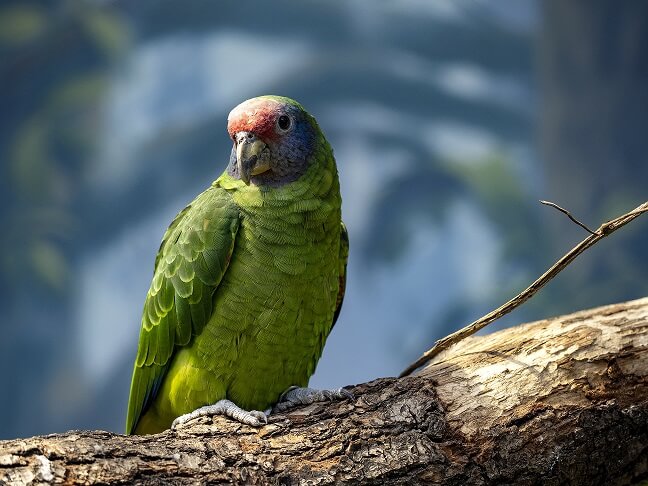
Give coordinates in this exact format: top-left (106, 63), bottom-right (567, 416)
top-left (227, 96), bottom-right (320, 186)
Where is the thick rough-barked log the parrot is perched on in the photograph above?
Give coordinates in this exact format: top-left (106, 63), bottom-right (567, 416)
top-left (0, 299), bottom-right (648, 485)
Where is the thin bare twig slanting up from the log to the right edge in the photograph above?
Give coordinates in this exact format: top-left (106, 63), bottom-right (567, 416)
top-left (400, 201), bottom-right (648, 377)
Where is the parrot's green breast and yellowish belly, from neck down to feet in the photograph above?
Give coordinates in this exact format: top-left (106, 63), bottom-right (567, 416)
top-left (159, 161), bottom-right (341, 416)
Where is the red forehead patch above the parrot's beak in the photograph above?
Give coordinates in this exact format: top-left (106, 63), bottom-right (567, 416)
top-left (227, 98), bottom-right (280, 140)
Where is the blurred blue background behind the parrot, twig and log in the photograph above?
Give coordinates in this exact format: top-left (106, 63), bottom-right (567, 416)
top-left (0, 0), bottom-right (648, 438)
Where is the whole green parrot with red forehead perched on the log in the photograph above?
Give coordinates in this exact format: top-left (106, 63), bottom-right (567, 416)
top-left (126, 96), bottom-right (350, 434)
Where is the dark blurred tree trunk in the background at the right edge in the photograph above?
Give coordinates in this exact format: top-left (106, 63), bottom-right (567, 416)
top-left (539, 0), bottom-right (648, 311)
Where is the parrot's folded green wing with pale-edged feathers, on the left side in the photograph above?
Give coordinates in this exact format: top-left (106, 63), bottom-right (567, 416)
top-left (126, 187), bottom-right (239, 434)
